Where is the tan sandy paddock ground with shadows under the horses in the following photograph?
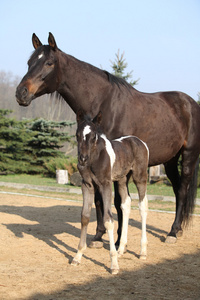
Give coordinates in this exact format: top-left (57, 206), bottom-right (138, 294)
top-left (0, 194), bottom-right (200, 300)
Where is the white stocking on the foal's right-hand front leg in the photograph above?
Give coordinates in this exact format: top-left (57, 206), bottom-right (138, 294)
top-left (105, 222), bottom-right (119, 274)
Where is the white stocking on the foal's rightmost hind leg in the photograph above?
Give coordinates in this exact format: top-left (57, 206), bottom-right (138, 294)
top-left (139, 195), bottom-right (148, 259)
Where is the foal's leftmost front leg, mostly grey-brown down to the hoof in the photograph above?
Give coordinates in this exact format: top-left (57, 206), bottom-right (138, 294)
top-left (72, 183), bottom-right (94, 266)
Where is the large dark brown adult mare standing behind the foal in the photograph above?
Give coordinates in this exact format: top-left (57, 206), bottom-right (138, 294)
top-left (16, 33), bottom-right (200, 244)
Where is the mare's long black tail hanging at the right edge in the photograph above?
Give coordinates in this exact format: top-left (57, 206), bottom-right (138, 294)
top-left (182, 158), bottom-right (199, 225)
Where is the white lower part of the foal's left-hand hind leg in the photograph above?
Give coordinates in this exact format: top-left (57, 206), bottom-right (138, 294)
top-left (118, 196), bottom-right (131, 257)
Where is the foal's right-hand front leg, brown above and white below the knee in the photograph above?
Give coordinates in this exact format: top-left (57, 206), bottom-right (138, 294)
top-left (101, 182), bottom-right (119, 274)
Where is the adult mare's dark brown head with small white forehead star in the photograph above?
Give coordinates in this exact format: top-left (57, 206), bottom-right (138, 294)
top-left (16, 33), bottom-right (59, 106)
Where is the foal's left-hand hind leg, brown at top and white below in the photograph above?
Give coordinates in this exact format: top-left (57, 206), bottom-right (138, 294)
top-left (118, 177), bottom-right (131, 257)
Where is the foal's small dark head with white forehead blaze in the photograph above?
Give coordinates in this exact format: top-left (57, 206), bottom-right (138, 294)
top-left (76, 111), bottom-right (102, 166)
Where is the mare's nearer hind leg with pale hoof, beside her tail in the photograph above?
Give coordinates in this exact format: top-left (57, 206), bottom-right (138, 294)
top-left (166, 149), bottom-right (199, 243)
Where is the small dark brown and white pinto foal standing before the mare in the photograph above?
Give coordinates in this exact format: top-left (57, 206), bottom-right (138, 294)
top-left (72, 112), bottom-right (149, 274)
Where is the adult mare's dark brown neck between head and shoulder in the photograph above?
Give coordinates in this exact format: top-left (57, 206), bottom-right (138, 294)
top-left (57, 51), bottom-right (110, 114)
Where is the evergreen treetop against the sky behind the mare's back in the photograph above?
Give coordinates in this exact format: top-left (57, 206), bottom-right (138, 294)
top-left (110, 50), bottom-right (139, 86)
